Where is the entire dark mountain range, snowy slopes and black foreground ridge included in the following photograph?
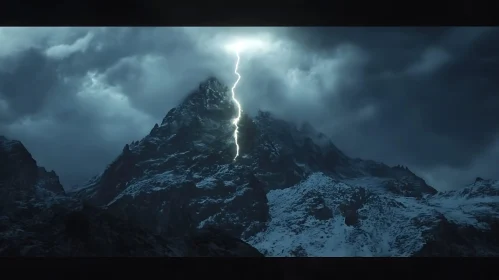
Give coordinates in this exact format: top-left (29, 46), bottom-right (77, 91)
top-left (0, 78), bottom-right (499, 256)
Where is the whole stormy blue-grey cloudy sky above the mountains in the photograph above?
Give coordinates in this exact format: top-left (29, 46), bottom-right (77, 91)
top-left (0, 27), bottom-right (499, 190)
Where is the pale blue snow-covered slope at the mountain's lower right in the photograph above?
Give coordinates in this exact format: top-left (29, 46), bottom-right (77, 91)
top-left (248, 173), bottom-right (499, 257)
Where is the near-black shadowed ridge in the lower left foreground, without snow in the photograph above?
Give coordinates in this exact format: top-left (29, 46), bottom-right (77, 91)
top-left (0, 136), bottom-right (262, 256)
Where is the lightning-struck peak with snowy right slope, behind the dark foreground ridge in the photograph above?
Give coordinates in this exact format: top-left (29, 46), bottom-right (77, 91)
top-left (73, 78), bottom-right (499, 256)
